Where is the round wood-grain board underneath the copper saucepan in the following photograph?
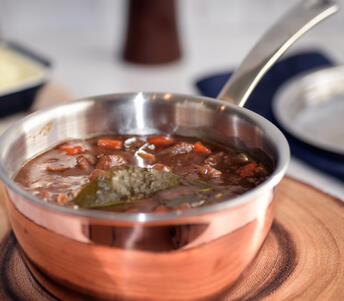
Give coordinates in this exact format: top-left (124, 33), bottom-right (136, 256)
top-left (0, 177), bottom-right (344, 301)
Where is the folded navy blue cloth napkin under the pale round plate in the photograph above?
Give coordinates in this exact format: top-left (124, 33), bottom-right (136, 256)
top-left (196, 51), bottom-right (344, 181)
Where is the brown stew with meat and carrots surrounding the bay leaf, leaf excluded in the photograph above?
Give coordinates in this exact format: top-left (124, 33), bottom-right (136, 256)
top-left (14, 135), bottom-right (270, 213)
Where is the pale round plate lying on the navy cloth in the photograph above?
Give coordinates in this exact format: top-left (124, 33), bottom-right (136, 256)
top-left (272, 66), bottom-right (344, 155)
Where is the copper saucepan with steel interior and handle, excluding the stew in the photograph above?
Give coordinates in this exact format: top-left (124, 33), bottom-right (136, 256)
top-left (0, 1), bottom-right (337, 301)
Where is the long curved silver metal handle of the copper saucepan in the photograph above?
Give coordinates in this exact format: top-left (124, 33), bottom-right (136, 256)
top-left (217, 0), bottom-right (339, 107)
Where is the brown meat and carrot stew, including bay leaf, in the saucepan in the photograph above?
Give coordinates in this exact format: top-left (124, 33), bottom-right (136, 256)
top-left (14, 135), bottom-right (271, 213)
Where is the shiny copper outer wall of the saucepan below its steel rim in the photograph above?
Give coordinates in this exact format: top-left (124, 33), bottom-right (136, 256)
top-left (7, 186), bottom-right (273, 300)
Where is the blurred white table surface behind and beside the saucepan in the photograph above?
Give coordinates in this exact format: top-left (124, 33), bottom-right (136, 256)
top-left (0, 0), bottom-right (344, 200)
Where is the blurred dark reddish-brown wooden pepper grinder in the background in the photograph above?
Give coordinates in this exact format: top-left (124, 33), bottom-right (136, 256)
top-left (123, 0), bottom-right (181, 64)
